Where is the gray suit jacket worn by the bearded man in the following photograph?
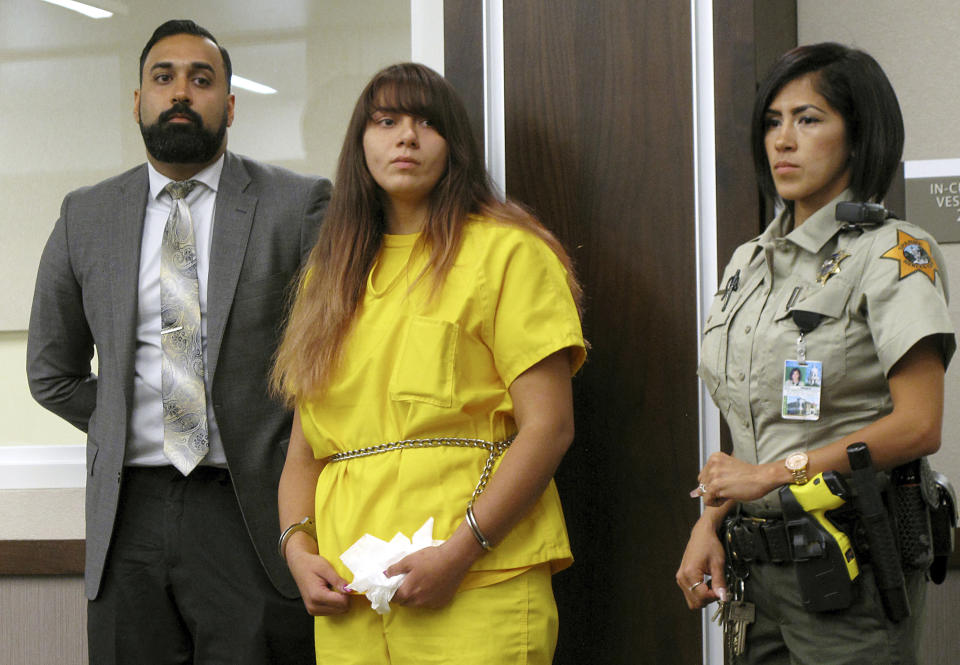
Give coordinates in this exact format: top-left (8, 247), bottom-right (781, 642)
top-left (27, 152), bottom-right (330, 599)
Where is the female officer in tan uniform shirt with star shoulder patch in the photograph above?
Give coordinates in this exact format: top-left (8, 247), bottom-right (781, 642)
top-left (677, 43), bottom-right (956, 665)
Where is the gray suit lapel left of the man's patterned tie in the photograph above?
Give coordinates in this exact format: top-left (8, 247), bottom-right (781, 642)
top-left (111, 165), bottom-right (150, 413)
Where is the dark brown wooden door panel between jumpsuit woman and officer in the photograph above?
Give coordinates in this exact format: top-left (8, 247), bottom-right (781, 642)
top-left (504, 6), bottom-right (700, 664)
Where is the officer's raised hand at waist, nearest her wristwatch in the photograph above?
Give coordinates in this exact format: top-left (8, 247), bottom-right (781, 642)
top-left (691, 453), bottom-right (786, 506)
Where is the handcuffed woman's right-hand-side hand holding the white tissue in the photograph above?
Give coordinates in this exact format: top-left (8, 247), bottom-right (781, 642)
top-left (384, 536), bottom-right (479, 609)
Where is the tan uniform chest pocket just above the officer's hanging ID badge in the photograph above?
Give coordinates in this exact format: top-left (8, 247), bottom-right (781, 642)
top-left (774, 275), bottom-right (853, 382)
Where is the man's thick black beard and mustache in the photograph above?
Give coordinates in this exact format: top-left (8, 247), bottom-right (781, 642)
top-left (140, 103), bottom-right (227, 164)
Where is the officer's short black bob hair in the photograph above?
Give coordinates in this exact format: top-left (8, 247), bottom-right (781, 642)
top-left (750, 42), bottom-right (903, 202)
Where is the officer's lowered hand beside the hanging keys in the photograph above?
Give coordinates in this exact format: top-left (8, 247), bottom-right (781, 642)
top-left (677, 502), bottom-right (733, 610)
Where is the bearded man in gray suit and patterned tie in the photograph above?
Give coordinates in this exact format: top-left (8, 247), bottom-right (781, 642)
top-left (27, 21), bottom-right (330, 665)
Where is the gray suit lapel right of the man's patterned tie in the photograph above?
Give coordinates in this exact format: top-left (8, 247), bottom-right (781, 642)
top-left (207, 152), bottom-right (257, 379)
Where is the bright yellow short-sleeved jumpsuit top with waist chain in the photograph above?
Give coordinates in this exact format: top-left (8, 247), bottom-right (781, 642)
top-left (299, 218), bottom-right (585, 588)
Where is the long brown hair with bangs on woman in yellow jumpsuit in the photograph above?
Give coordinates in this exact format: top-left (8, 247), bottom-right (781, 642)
top-left (271, 63), bottom-right (582, 405)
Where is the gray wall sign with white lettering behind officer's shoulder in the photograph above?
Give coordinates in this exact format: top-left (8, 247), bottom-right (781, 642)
top-left (903, 159), bottom-right (960, 243)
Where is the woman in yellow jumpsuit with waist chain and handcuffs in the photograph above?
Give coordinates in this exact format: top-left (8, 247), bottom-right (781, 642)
top-left (275, 64), bottom-right (584, 664)
